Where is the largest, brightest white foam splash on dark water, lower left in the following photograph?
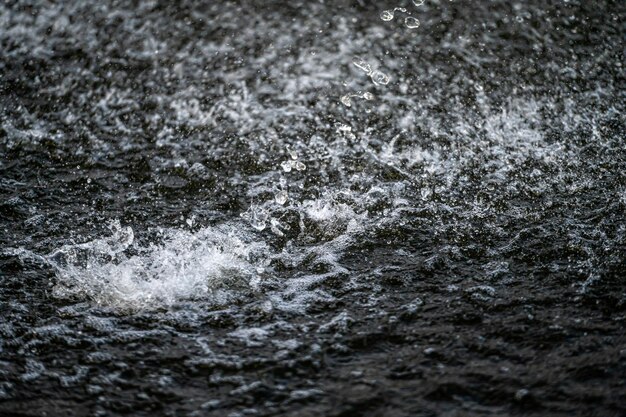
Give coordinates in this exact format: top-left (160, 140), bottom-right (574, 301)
top-left (48, 222), bottom-right (264, 309)
